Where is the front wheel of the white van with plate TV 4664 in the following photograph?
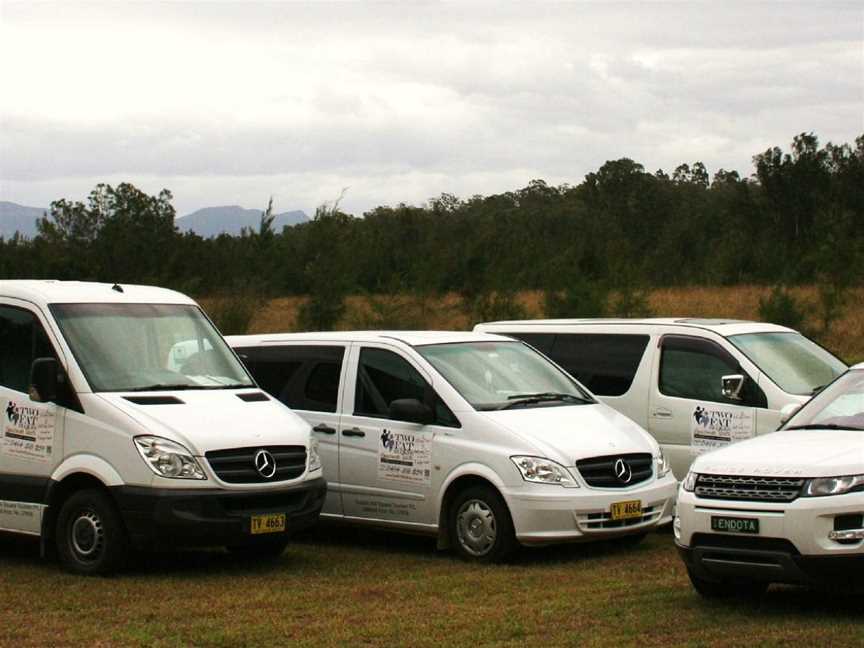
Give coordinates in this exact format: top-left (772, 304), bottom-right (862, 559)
top-left (447, 486), bottom-right (516, 563)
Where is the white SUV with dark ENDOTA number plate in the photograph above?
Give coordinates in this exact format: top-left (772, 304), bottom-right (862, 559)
top-left (674, 365), bottom-right (864, 597)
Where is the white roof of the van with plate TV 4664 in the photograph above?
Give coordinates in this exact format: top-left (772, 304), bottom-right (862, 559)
top-left (226, 331), bottom-right (512, 346)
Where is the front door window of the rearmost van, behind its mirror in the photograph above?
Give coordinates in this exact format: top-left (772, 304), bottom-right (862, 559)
top-left (658, 336), bottom-right (767, 407)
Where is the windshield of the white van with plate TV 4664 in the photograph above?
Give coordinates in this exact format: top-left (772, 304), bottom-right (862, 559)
top-left (417, 342), bottom-right (596, 410)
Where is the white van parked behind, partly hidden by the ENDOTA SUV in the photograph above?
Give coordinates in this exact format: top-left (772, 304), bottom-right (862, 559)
top-left (474, 319), bottom-right (846, 479)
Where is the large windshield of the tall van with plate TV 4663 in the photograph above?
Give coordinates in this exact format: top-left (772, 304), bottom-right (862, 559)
top-left (51, 304), bottom-right (254, 392)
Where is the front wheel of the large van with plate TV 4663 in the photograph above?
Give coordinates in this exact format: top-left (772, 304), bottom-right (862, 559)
top-left (55, 489), bottom-right (129, 576)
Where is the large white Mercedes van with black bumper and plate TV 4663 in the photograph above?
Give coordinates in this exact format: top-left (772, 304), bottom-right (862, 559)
top-left (0, 281), bottom-right (326, 574)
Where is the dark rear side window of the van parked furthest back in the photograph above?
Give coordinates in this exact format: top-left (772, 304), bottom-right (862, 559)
top-left (549, 333), bottom-right (650, 396)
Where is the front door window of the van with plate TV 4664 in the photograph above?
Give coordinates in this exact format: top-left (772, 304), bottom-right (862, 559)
top-left (354, 347), bottom-right (459, 427)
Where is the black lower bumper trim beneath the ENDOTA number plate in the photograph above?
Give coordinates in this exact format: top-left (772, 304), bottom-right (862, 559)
top-left (676, 543), bottom-right (864, 590)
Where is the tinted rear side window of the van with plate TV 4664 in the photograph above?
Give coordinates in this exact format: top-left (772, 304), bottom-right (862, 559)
top-left (237, 345), bottom-right (345, 412)
